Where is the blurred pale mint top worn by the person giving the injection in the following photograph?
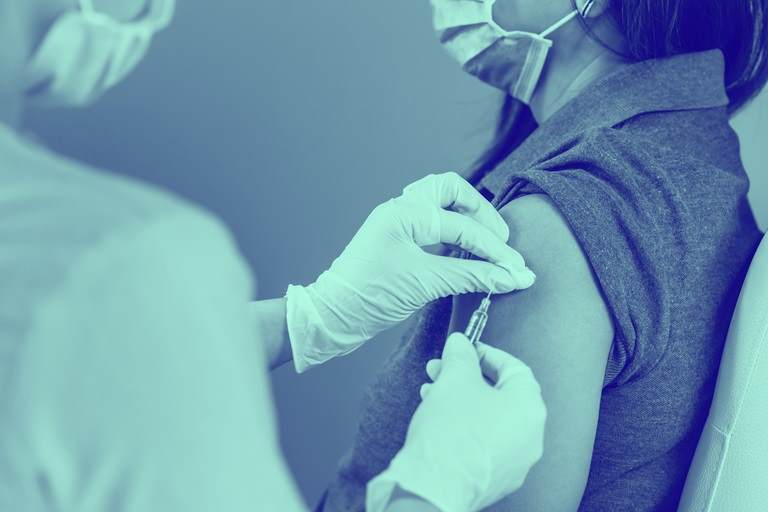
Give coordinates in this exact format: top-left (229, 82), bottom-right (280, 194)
top-left (0, 128), bottom-right (303, 512)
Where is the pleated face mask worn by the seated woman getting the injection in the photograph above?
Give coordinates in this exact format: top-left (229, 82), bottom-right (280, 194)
top-left (432, 0), bottom-right (594, 104)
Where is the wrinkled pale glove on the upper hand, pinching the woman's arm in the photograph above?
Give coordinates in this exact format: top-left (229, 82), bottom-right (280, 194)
top-left (286, 173), bottom-right (535, 372)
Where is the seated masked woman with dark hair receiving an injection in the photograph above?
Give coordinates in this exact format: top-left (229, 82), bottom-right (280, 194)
top-left (320, 0), bottom-right (768, 512)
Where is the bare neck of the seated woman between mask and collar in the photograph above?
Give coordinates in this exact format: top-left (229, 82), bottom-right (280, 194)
top-left (531, 25), bottom-right (627, 124)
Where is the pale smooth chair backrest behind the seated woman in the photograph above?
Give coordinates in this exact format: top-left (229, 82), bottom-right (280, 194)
top-left (678, 236), bottom-right (768, 512)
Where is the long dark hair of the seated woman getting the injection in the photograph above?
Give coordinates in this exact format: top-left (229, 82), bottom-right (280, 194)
top-left (471, 0), bottom-right (768, 183)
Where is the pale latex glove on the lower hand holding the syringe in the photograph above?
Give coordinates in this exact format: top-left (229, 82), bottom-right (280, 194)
top-left (366, 334), bottom-right (546, 512)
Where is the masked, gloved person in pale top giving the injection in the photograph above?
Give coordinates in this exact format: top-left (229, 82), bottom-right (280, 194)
top-left (0, 0), bottom-right (545, 512)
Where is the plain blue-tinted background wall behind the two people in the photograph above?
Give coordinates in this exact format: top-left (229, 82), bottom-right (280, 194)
top-left (28, 0), bottom-right (768, 503)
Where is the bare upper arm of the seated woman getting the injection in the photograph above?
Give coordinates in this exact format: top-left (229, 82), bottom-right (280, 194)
top-left (452, 195), bottom-right (613, 511)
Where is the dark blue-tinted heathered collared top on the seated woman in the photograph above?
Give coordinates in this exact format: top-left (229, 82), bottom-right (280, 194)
top-left (320, 50), bottom-right (761, 511)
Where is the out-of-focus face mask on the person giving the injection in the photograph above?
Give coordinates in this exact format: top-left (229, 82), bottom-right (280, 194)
top-left (25, 0), bottom-right (175, 106)
